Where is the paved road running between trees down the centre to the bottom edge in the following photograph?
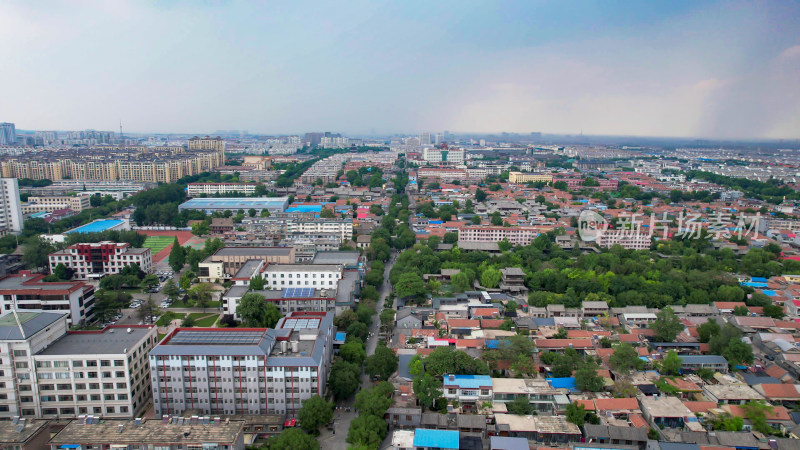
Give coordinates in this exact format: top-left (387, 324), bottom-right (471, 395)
top-left (318, 253), bottom-right (397, 450)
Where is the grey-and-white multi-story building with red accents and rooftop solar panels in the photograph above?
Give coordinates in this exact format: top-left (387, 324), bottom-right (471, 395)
top-left (150, 312), bottom-right (336, 417)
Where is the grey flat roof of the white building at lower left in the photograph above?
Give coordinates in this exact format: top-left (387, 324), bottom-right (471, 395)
top-left (37, 326), bottom-right (152, 356)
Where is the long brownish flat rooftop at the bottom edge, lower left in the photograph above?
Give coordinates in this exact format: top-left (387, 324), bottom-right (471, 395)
top-left (50, 419), bottom-right (244, 447)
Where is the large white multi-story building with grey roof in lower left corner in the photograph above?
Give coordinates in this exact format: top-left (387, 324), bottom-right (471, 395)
top-left (0, 311), bottom-right (158, 418)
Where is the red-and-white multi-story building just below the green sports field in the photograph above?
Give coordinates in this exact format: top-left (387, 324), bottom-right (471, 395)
top-left (49, 241), bottom-right (153, 280)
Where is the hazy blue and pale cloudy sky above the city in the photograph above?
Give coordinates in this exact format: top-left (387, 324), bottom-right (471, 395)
top-left (0, 0), bottom-right (800, 139)
